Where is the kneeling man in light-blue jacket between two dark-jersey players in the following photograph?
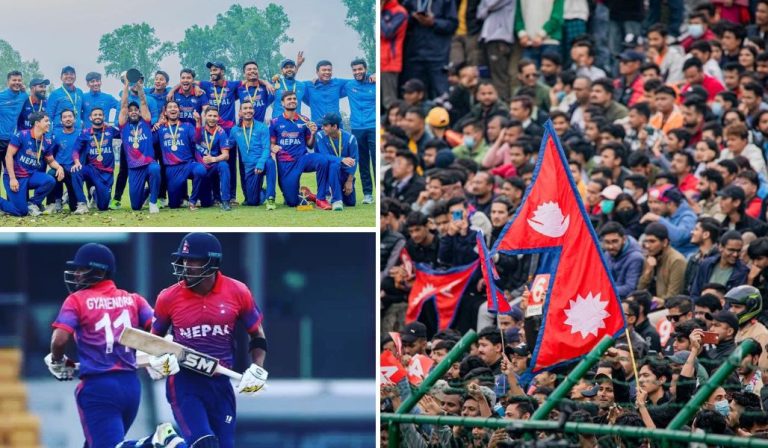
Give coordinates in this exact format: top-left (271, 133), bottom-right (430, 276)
top-left (229, 99), bottom-right (277, 210)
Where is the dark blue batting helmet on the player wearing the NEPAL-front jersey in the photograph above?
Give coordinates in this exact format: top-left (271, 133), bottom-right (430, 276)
top-left (171, 232), bottom-right (222, 288)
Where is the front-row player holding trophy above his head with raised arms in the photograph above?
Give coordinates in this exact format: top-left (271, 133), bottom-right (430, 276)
top-left (118, 81), bottom-right (160, 214)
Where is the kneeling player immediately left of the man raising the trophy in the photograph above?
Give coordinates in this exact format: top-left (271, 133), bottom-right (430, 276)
top-left (72, 107), bottom-right (120, 215)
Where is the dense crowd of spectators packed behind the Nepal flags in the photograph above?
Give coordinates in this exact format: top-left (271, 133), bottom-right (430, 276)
top-left (379, 0), bottom-right (768, 447)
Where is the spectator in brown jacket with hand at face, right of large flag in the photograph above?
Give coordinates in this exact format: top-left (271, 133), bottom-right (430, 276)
top-left (637, 222), bottom-right (686, 306)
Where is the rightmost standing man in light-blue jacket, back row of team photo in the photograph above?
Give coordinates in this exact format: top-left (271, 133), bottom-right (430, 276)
top-left (342, 59), bottom-right (377, 204)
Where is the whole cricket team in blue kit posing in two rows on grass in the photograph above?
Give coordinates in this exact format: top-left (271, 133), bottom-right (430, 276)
top-left (0, 53), bottom-right (375, 216)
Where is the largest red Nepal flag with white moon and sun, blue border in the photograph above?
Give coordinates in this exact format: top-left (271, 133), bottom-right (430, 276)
top-left (493, 122), bottom-right (625, 374)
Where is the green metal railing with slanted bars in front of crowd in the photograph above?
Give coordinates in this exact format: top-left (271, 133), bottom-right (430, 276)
top-left (381, 331), bottom-right (768, 448)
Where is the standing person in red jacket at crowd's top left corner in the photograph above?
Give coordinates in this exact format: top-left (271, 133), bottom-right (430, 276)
top-left (381, 0), bottom-right (408, 110)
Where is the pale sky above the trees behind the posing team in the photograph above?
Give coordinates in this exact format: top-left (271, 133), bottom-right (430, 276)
top-left (0, 0), bottom-right (366, 97)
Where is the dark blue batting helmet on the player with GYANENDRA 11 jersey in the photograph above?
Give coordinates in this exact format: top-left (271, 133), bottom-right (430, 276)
top-left (64, 243), bottom-right (115, 293)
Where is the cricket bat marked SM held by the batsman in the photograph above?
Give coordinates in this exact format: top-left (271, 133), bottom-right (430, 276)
top-left (120, 327), bottom-right (243, 381)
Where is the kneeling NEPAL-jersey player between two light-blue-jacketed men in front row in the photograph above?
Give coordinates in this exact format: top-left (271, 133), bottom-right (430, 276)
top-left (269, 91), bottom-right (344, 210)
